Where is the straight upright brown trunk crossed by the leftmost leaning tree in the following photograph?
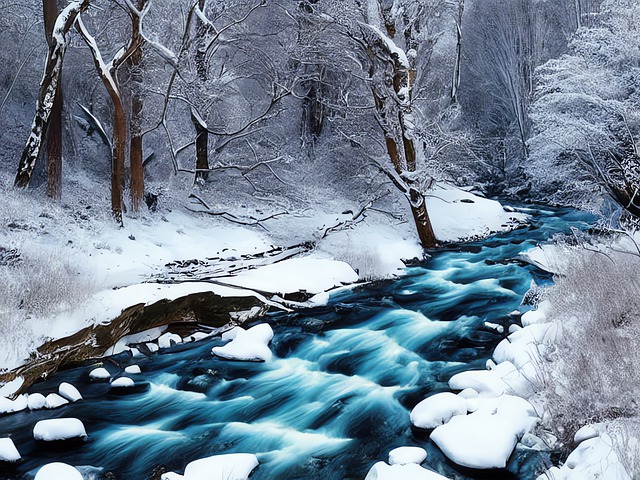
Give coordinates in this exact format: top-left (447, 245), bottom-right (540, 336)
top-left (42, 0), bottom-right (63, 200)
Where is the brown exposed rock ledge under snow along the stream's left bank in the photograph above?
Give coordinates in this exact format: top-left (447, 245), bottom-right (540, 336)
top-left (0, 292), bottom-right (269, 395)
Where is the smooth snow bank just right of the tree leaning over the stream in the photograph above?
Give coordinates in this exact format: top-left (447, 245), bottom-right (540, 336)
top-left (426, 183), bottom-right (528, 242)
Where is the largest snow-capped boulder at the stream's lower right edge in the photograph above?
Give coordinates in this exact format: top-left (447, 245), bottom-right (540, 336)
top-left (431, 409), bottom-right (518, 469)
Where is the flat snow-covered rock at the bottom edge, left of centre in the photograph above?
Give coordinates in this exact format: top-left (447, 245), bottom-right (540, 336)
top-left (161, 453), bottom-right (258, 480)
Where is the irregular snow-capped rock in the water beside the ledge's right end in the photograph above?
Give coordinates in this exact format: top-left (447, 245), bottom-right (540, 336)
top-left (211, 323), bottom-right (273, 362)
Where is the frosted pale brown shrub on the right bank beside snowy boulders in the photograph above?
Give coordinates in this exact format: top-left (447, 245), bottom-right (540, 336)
top-left (541, 247), bottom-right (640, 446)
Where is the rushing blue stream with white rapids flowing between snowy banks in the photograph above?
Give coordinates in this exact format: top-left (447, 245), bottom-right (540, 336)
top-left (0, 210), bottom-right (590, 480)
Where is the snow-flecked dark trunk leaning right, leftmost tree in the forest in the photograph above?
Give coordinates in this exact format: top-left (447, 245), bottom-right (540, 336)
top-left (14, 0), bottom-right (89, 188)
